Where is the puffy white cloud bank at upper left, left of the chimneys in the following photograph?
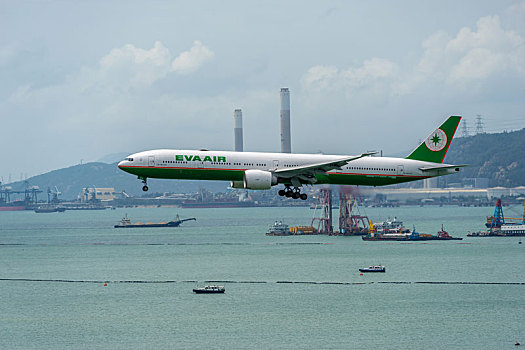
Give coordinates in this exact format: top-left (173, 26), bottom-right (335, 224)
top-left (6, 41), bottom-right (214, 110)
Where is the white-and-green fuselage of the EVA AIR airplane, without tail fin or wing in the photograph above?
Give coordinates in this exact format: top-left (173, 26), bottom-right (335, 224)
top-left (118, 149), bottom-right (459, 186)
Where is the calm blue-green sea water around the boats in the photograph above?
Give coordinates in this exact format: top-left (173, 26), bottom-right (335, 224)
top-left (0, 207), bottom-right (525, 349)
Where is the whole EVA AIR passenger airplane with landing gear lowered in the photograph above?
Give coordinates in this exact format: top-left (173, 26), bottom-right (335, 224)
top-left (118, 116), bottom-right (466, 200)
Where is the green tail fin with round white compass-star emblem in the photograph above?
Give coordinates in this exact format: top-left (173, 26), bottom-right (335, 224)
top-left (406, 116), bottom-right (461, 163)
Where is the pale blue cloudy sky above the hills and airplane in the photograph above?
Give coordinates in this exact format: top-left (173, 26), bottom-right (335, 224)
top-left (0, 0), bottom-right (525, 183)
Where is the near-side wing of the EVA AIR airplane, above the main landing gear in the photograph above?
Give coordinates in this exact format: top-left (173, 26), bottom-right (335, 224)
top-left (273, 152), bottom-right (377, 186)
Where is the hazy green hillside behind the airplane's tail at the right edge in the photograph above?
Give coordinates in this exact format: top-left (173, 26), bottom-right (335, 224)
top-left (445, 128), bottom-right (525, 187)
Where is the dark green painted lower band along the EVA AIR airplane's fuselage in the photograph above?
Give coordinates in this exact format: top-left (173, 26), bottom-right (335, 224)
top-left (121, 167), bottom-right (426, 186)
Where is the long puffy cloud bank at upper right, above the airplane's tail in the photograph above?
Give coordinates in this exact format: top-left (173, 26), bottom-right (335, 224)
top-left (301, 14), bottom-right (525, 100)
